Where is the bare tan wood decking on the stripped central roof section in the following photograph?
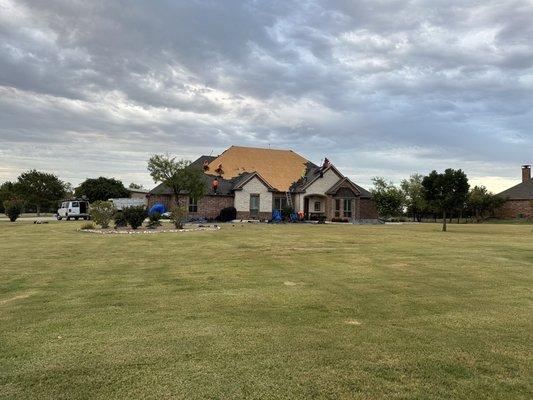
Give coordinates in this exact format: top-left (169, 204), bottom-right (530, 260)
top-left (209, 146), bottom-right (308, 192)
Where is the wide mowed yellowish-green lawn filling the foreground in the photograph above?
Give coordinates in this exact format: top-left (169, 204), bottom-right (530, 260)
top-left (0, 222), bottom-right (533, 399)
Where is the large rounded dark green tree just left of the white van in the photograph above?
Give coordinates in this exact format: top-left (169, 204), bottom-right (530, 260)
top-left (16, 169), bottom-right (65, 216)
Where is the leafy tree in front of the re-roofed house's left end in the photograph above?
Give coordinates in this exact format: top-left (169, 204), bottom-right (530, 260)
top-left (148, 154), bottom-right (205, 205)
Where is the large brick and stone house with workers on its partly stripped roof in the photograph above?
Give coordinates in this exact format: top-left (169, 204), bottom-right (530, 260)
top-left (148, 146), bottom-right (378, 220)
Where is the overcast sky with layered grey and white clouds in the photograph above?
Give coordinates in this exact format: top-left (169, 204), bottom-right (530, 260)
top-left (0, 0), bottom-right (533, 191)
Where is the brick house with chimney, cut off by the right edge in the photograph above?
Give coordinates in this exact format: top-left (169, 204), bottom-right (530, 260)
top-left (497, 165), bottom-right (533, 218)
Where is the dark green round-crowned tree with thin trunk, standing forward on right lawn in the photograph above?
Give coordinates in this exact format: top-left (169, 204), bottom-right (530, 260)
top-left (422, 168), bottom-right (470, 232)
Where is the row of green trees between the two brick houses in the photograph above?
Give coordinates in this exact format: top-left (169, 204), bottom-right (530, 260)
top-left (371, 168), bottom-right (505, 231)
